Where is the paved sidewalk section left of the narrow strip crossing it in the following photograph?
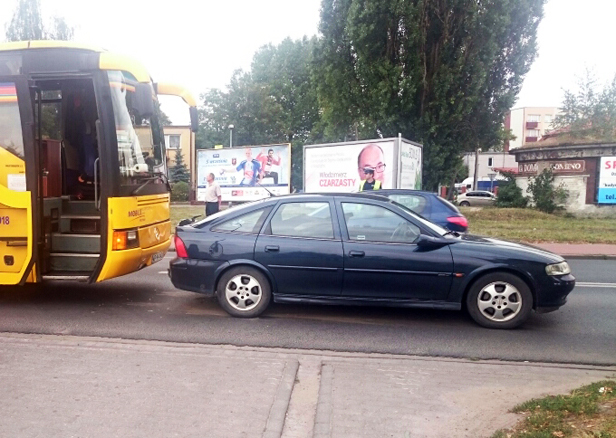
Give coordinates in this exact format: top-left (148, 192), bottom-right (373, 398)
top-left (0, 337), bottom-right (297, 438)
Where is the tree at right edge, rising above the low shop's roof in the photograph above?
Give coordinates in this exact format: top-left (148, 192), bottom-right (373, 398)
top-left (554, 70), bottom-right (616, 141)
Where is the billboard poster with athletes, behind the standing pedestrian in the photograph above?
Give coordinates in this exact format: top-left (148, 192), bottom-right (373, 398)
top-left (197, 144), bottom-right (291, 202)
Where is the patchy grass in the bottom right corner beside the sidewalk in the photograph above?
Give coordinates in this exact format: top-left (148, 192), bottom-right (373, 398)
top-left (492, 380), bottom-right (616, 438)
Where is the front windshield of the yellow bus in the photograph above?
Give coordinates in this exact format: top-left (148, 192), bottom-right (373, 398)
top-left (108, 71), bottom-right (167, 185)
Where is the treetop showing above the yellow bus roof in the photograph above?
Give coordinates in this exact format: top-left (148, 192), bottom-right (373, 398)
top-left (6, 0), bottom-right (75, 41)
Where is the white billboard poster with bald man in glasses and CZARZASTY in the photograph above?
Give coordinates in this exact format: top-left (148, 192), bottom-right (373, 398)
top-left (304, 139), bottom-right (397, 193)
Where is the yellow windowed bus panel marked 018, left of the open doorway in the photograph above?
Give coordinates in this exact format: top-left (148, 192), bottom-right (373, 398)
top-left (0, 76), bottom-right (38, 285)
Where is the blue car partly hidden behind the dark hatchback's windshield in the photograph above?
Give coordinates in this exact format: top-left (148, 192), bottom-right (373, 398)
top-left (362, 189), bottom-right (468, 233)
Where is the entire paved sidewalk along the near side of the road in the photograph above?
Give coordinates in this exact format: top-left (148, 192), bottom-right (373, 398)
top-left (0, 334), bottom-right (616, 438)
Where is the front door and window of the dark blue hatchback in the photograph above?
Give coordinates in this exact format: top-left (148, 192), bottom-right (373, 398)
top-left (336, 200), bottom-right (453, 300)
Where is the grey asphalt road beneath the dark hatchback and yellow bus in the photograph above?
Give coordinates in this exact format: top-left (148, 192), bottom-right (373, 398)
top-left (0, 256), bottom-right (616, 365)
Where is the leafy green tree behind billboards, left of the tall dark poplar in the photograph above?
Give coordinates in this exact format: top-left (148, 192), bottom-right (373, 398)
top-left (196, 38), bottom-right (321, 188)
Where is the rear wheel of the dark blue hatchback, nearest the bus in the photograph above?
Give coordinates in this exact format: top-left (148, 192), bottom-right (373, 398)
top-left (216, 266), bottom-right (272, 318)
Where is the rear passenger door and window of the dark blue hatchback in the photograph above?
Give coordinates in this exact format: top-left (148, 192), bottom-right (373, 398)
top-left (255, 201), bottom-right (343, 296)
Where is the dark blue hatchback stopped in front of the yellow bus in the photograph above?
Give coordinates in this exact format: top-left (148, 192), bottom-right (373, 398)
top-left (169, 194), bottom-right (575, 328)
